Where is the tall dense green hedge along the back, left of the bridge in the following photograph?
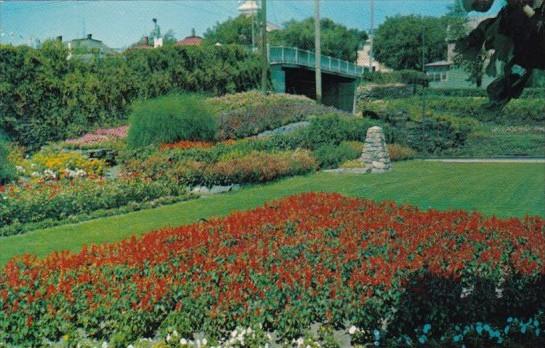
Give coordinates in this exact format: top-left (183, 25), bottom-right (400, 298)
top-left (0, 41), bottom-right (260, 148)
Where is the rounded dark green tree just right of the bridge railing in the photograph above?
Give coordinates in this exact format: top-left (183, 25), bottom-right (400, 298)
top-left (373, 15), bottom-right (447, 70)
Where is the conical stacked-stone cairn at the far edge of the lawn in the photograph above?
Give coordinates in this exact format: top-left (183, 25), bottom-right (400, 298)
top-left (360, 127), bottom-right (392, 173)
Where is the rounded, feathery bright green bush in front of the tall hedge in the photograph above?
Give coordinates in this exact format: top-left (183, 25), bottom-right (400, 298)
top-left (127, 95), bottom-right (216, 148)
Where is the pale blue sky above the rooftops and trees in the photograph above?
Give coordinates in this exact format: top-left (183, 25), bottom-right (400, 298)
top-left (0, 0), bottom-right (499, 48)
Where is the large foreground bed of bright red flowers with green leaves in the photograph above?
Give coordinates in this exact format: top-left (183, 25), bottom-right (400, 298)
top-left (0, 193), bottom-right (545, 346)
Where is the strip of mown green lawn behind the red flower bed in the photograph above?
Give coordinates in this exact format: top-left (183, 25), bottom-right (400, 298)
top-left (0, 161), bottom-right (545, 265)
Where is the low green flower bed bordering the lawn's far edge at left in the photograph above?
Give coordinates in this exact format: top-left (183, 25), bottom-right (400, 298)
top-left (0, 179), bottom-right (186, 236)
